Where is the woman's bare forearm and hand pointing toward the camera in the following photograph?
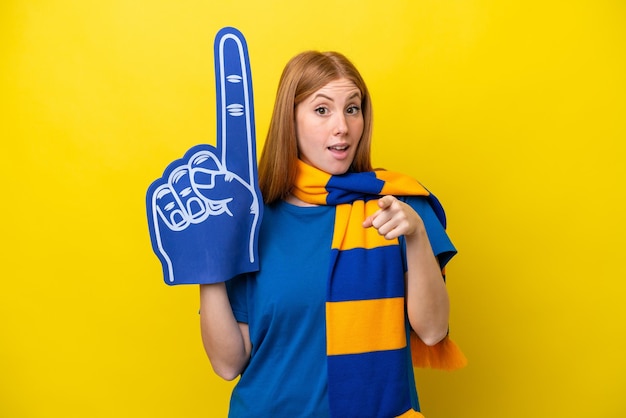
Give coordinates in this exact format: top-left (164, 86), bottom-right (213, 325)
top-left (363, 196), bottom-right (450, 345)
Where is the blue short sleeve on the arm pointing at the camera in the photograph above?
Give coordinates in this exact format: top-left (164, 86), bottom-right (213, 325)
top-left (401, 196), bottom-right (457, 269)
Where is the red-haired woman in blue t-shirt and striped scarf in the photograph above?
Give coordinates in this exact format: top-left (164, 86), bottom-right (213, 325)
top-left (200, 51), bottom-right (455, 417)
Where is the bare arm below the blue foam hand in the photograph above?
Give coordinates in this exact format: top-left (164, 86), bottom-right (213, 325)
top-left (200, 283), bottom-right (252, 380)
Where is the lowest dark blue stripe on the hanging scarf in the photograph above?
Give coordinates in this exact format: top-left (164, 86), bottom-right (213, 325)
top-left (328, 349), bottom-right (411, 418)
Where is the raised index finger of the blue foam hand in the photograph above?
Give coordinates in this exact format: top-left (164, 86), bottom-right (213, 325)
top-left (215, 27), bottom-right (256, 184)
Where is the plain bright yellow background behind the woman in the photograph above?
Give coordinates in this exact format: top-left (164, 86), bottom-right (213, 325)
top-left (0, 0), bottom-right (626, 418)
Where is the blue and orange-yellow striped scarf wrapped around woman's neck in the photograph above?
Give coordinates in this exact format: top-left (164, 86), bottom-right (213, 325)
top-left (292, 160), bottom-right (465, 418)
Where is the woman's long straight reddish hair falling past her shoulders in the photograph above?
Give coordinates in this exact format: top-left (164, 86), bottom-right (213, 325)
top-left (259, 51), bottom-right (372, 204)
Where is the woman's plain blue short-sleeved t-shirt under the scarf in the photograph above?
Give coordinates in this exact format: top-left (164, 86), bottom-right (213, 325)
top-left (227, 198), bottom-right (456, 417)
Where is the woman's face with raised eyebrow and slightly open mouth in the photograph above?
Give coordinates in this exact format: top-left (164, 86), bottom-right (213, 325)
top-left (296, 78), bottom-right (363, 174)
